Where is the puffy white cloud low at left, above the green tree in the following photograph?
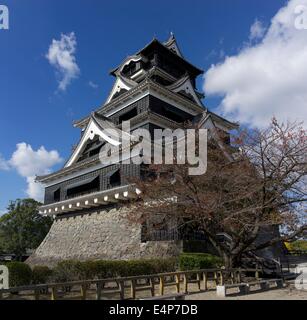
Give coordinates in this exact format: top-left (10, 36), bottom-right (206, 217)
top-left (8, 142), bottom-right (62, 201)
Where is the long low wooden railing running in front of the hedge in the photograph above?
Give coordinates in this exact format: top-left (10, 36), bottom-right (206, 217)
top-left (0, 269), bottom-right (261, 300)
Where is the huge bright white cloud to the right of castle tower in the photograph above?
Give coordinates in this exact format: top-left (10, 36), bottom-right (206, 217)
top-left (204, 0), bottom-right (307, 127)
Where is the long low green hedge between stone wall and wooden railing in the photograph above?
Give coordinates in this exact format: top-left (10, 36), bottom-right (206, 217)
top-left (1, 253), bottom-right (222, 287)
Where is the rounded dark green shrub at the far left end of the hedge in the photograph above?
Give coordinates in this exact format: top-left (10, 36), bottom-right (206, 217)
top-left (6, 261), bottom-right (32, 288)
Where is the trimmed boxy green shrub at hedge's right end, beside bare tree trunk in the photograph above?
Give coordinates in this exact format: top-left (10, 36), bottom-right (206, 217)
top-left (179, 253), bottom-right (223, 271)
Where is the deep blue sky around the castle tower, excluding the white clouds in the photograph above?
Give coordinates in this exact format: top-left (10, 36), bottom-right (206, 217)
top-left (0, 0), bottom-right (306, 212)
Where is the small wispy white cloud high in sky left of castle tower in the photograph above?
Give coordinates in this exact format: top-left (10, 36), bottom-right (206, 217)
top-left (46, 32), bottom-right (80, 91)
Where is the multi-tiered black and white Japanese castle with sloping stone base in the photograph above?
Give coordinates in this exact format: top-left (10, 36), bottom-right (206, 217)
top-left (28, 34), bottom-right (286, 266)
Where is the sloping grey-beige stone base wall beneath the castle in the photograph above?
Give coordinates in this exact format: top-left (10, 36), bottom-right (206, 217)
top-left (27, 207), bottom-right (181, 267)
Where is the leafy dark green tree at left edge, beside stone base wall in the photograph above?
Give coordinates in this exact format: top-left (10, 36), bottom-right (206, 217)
top-left (0, 199), bottom-right (52, 260)
